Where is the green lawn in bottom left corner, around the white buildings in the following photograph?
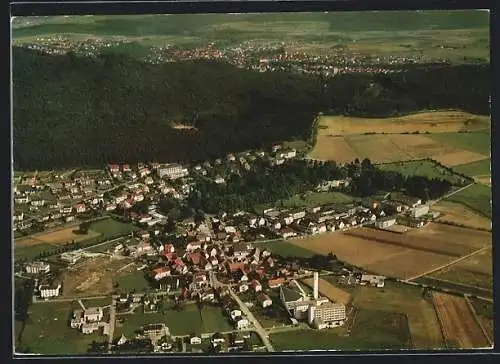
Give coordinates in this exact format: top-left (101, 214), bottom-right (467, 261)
top-left (15, 302), bottom-right (106, 355)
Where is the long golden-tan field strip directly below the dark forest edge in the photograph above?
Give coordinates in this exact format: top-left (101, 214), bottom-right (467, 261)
top-left (318, 111), bottom-right (490, 135)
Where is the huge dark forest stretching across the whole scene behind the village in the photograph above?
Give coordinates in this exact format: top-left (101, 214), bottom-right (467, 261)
top-left (13, 47), bottom-right (489, 169)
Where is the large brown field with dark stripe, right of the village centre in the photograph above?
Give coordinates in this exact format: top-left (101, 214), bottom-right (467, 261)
top-left (291, 223), bottom-right (491, 279)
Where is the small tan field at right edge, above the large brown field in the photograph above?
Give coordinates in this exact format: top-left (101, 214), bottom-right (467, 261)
top-left (432, 201), bottom-right (491, 230)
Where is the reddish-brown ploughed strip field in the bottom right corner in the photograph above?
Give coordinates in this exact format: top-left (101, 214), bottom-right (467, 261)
top-left (432, 292), bottom-right (490, 349)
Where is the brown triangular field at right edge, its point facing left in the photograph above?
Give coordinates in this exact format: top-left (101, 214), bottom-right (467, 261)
top-left (429, 249), bottom-right (493, 290)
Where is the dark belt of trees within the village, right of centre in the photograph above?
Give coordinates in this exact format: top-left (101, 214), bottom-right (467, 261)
top-left (187, 158), bottom-right (452, 213)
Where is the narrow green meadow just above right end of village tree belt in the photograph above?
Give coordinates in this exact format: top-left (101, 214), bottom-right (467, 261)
top-left (377, 161), bottom-right (462, 185)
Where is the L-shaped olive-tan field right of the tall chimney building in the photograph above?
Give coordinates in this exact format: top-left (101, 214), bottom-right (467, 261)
top-left (352, 281), bottom-right (444, 349)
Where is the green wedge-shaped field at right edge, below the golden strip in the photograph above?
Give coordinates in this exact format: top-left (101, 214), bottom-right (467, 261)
top-left (427, 129), bottom-right (491, 157)
